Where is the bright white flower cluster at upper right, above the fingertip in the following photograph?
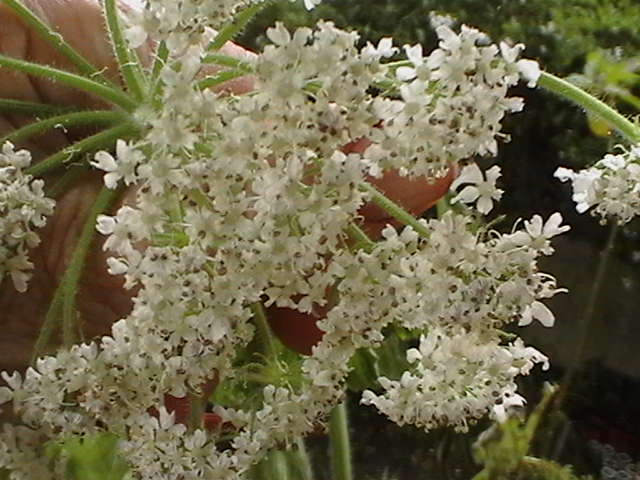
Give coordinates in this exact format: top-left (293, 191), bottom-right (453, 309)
top-left (367, 25), bottom-right (536, 176)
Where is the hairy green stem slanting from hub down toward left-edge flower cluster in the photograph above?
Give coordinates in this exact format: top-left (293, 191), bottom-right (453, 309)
top-left (26, 122), bottom-right (136, 176)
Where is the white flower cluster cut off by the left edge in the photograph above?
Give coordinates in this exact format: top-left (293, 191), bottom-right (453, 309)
top-left (0, 142), bottom-right (55, 292)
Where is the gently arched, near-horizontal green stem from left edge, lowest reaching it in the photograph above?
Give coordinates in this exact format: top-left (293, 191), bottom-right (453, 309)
top-left (0, 110), bottom-right (126, 145)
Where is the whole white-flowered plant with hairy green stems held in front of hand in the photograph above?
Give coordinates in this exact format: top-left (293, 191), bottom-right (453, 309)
top-left (0, 0), bottom-right (638, 479)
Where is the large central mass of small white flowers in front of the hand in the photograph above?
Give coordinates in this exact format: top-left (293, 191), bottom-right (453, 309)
top-left (0, 15), bottom-right (556, 480)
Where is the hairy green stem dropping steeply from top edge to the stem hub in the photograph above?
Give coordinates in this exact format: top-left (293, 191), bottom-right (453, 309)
top-left (104, 0), bottom-right (146, 100)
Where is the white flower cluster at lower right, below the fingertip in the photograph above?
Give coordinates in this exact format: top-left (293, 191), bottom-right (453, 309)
top-left (314, 213), bottom-right (569, 429)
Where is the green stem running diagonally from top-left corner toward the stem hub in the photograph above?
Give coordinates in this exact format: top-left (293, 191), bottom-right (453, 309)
top-left (2, 0), bottom-right (113, 85)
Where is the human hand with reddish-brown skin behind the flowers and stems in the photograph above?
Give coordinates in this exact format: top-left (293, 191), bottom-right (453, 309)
top-left (0, 0), bottom-right (455, 371)
